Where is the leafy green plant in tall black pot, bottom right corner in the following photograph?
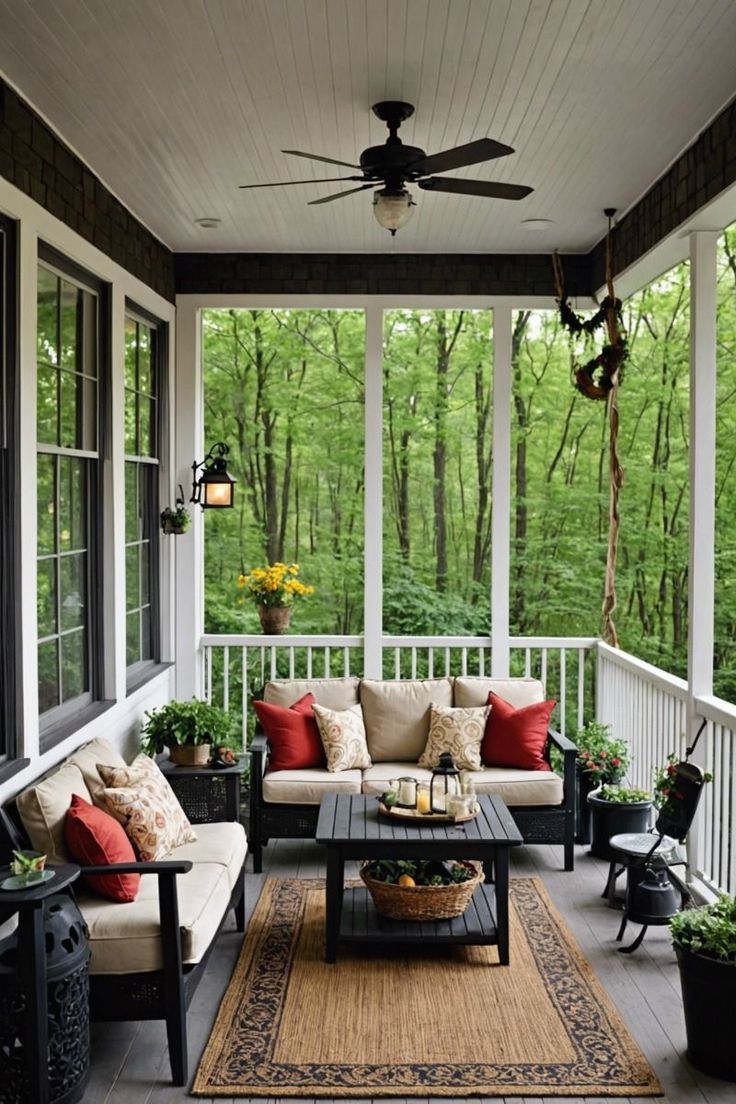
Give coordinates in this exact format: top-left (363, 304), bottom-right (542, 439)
top-left (670, 894), bottom-right (736, 1081)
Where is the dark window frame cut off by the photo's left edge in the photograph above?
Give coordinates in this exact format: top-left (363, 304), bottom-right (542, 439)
top-left (0, 214), bottom-right (29, 783)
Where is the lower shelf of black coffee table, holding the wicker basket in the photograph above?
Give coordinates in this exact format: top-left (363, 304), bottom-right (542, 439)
top-left (339, 882), bottom-right (498, 944)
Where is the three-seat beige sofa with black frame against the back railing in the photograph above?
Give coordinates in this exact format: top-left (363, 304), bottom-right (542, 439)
top-left (248, 677), bottom-right (576, 871)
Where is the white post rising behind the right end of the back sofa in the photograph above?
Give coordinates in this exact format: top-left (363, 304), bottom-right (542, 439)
top-left (491, 307), bottom-right (511, 678)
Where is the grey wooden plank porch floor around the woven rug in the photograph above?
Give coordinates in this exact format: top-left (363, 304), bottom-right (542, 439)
top-left (84, 840), bottom-right (736, 1104)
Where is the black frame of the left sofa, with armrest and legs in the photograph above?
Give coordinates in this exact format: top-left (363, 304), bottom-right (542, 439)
top-left (0, 786), bottom-right (245, 1085)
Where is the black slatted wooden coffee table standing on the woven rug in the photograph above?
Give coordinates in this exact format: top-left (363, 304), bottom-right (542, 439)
top-left (316, 794), bottom-right (523, 966)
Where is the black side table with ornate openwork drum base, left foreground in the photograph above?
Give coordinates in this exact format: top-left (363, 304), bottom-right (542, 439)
top-left (0, 863), bottom-right (89, 1104)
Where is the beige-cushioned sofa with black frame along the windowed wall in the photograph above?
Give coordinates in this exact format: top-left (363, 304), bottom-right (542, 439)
top-left (0, 740), bottom-right (247, 1084)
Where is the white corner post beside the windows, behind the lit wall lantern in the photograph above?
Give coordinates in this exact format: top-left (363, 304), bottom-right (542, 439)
top-left (173, 299), bottom-right (204, 699)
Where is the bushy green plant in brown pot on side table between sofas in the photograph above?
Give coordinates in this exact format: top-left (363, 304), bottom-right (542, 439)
top-left (140, 698), bottom-right (231, 766)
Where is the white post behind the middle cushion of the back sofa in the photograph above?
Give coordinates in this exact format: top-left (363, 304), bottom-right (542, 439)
top-left (363, 304), bottom-right (383, 679)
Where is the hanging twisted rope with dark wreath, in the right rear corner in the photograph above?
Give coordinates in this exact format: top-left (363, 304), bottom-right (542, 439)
top-left (552, 208), bottom-right (628, 648)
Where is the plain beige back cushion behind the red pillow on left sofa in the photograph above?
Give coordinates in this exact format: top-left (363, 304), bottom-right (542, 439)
top-left (15, 762), bottom-right (92, 863)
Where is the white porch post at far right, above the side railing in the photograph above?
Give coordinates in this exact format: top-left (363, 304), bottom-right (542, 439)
top-left (688, 231), bottom-right (717, 861)
